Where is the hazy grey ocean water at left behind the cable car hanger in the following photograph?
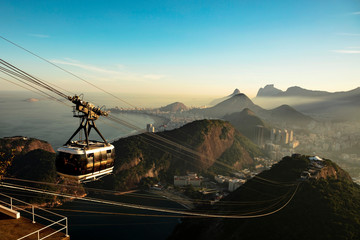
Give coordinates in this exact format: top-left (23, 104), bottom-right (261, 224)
top-left (0, 92), bottom-right (154, 150)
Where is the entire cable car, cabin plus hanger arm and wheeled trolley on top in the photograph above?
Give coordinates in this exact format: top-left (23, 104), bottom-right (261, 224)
top-left (56, 95), bottom-right (115, 182)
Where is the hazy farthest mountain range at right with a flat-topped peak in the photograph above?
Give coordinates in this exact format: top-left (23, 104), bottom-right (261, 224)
top-left (253, 85), bottom-right (360, 121)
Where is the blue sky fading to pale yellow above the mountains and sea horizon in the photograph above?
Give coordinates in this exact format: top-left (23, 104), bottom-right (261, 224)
top-left (0, 0), bottom-right (360, 100)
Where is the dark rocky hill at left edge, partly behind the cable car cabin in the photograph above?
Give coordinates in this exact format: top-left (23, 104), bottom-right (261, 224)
top-left (0, 137), bottom-right (86, 205)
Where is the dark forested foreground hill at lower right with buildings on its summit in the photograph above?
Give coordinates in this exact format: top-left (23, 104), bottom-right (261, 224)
top-left (168, 156), bottom-right (360, 240)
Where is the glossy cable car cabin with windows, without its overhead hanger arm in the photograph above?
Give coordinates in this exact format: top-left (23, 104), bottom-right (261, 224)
top-left (56, 141), bottom-right (115, 182)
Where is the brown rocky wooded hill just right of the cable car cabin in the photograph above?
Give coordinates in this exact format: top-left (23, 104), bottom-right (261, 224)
top-left (103, 120), bottom-right (263, 189)
